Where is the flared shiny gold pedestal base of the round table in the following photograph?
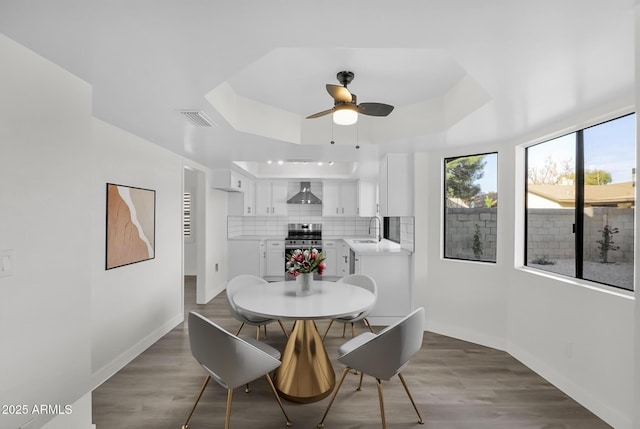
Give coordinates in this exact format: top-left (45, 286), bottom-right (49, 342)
top-left (273, 320), bottom-right (336, 404)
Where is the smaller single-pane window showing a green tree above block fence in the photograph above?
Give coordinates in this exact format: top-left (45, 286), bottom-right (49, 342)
top-left (444, 153), bottom-right (498, 262)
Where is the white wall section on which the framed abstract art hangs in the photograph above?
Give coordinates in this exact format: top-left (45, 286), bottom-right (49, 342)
top-left (91, 119), bottom-right (183, 384)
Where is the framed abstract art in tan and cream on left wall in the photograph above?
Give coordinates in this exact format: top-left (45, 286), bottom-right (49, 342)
top-left (105, 183), bottom-right (156, 270)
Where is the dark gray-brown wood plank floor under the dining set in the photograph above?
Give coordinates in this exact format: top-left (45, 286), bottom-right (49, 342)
top-left (93, 281), bottom-right (610, 429)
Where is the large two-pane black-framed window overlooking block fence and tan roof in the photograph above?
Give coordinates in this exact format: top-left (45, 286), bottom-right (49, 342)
top-left (525, 114), bottom-right (636, 290)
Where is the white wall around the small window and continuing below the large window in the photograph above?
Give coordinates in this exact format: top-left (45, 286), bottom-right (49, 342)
top-left (413, 106), bottom-right (638, 428)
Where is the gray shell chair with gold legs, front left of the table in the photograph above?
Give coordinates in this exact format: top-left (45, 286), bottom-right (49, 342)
top-left (182, 311), bottom-right (291, 429)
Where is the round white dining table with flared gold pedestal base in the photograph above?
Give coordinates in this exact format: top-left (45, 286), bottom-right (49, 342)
top-left (233, 280), bottom-right (376, 403)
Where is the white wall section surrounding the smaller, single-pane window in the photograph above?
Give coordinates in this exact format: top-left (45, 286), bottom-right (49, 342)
top-left (414, 148), bottom-right (508, 349)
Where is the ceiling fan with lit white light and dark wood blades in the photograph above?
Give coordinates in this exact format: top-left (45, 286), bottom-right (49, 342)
top-left (307, 71), bottom-right (393, 125)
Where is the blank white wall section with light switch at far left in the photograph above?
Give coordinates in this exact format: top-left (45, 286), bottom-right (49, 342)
top-left (0, 31), bottom-right (93, 428)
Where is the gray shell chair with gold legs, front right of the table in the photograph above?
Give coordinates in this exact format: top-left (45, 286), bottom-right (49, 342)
top-left (318, 307), bottom-right (424, 429)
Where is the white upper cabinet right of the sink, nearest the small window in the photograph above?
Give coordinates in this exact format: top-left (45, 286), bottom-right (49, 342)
top-left (380, 153), bottom-right (413, 216)
